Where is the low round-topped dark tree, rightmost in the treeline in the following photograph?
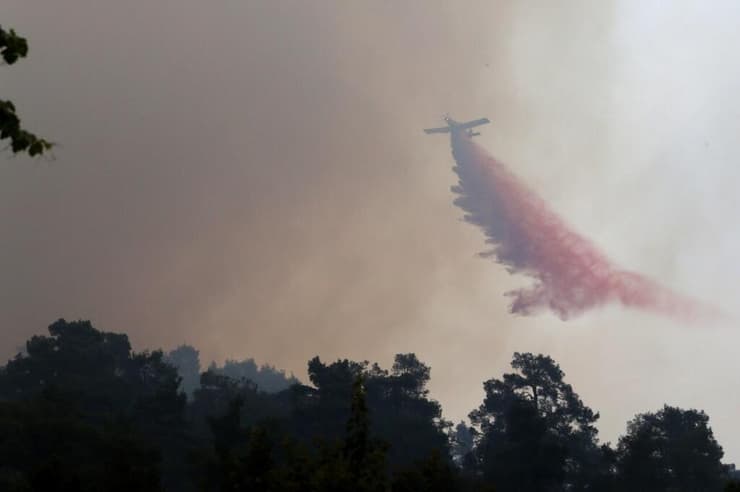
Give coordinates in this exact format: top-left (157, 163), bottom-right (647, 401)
top-left (617, 405), bottom-right (725, 491)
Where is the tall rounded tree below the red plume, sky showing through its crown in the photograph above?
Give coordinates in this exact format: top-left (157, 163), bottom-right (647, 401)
top-left (470, 353), bottom-right (600, 491)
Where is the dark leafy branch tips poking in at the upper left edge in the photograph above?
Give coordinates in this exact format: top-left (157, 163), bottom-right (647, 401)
top-left (0, 27), bottom-right (53, 157)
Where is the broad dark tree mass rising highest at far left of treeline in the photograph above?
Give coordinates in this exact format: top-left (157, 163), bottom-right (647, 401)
top-left (0, 319), bottom-right (186, 488)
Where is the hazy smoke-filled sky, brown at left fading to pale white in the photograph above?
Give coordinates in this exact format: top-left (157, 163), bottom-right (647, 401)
top-left (0, 0), bottom-right (740, 460)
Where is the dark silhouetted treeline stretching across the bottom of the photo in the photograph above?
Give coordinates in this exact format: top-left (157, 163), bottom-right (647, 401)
top-left (0, 320), bottom-right (740, 492)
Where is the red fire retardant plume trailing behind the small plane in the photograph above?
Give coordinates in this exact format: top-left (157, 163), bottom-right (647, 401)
top-left (452, 131), bottom-right (717, 320)
